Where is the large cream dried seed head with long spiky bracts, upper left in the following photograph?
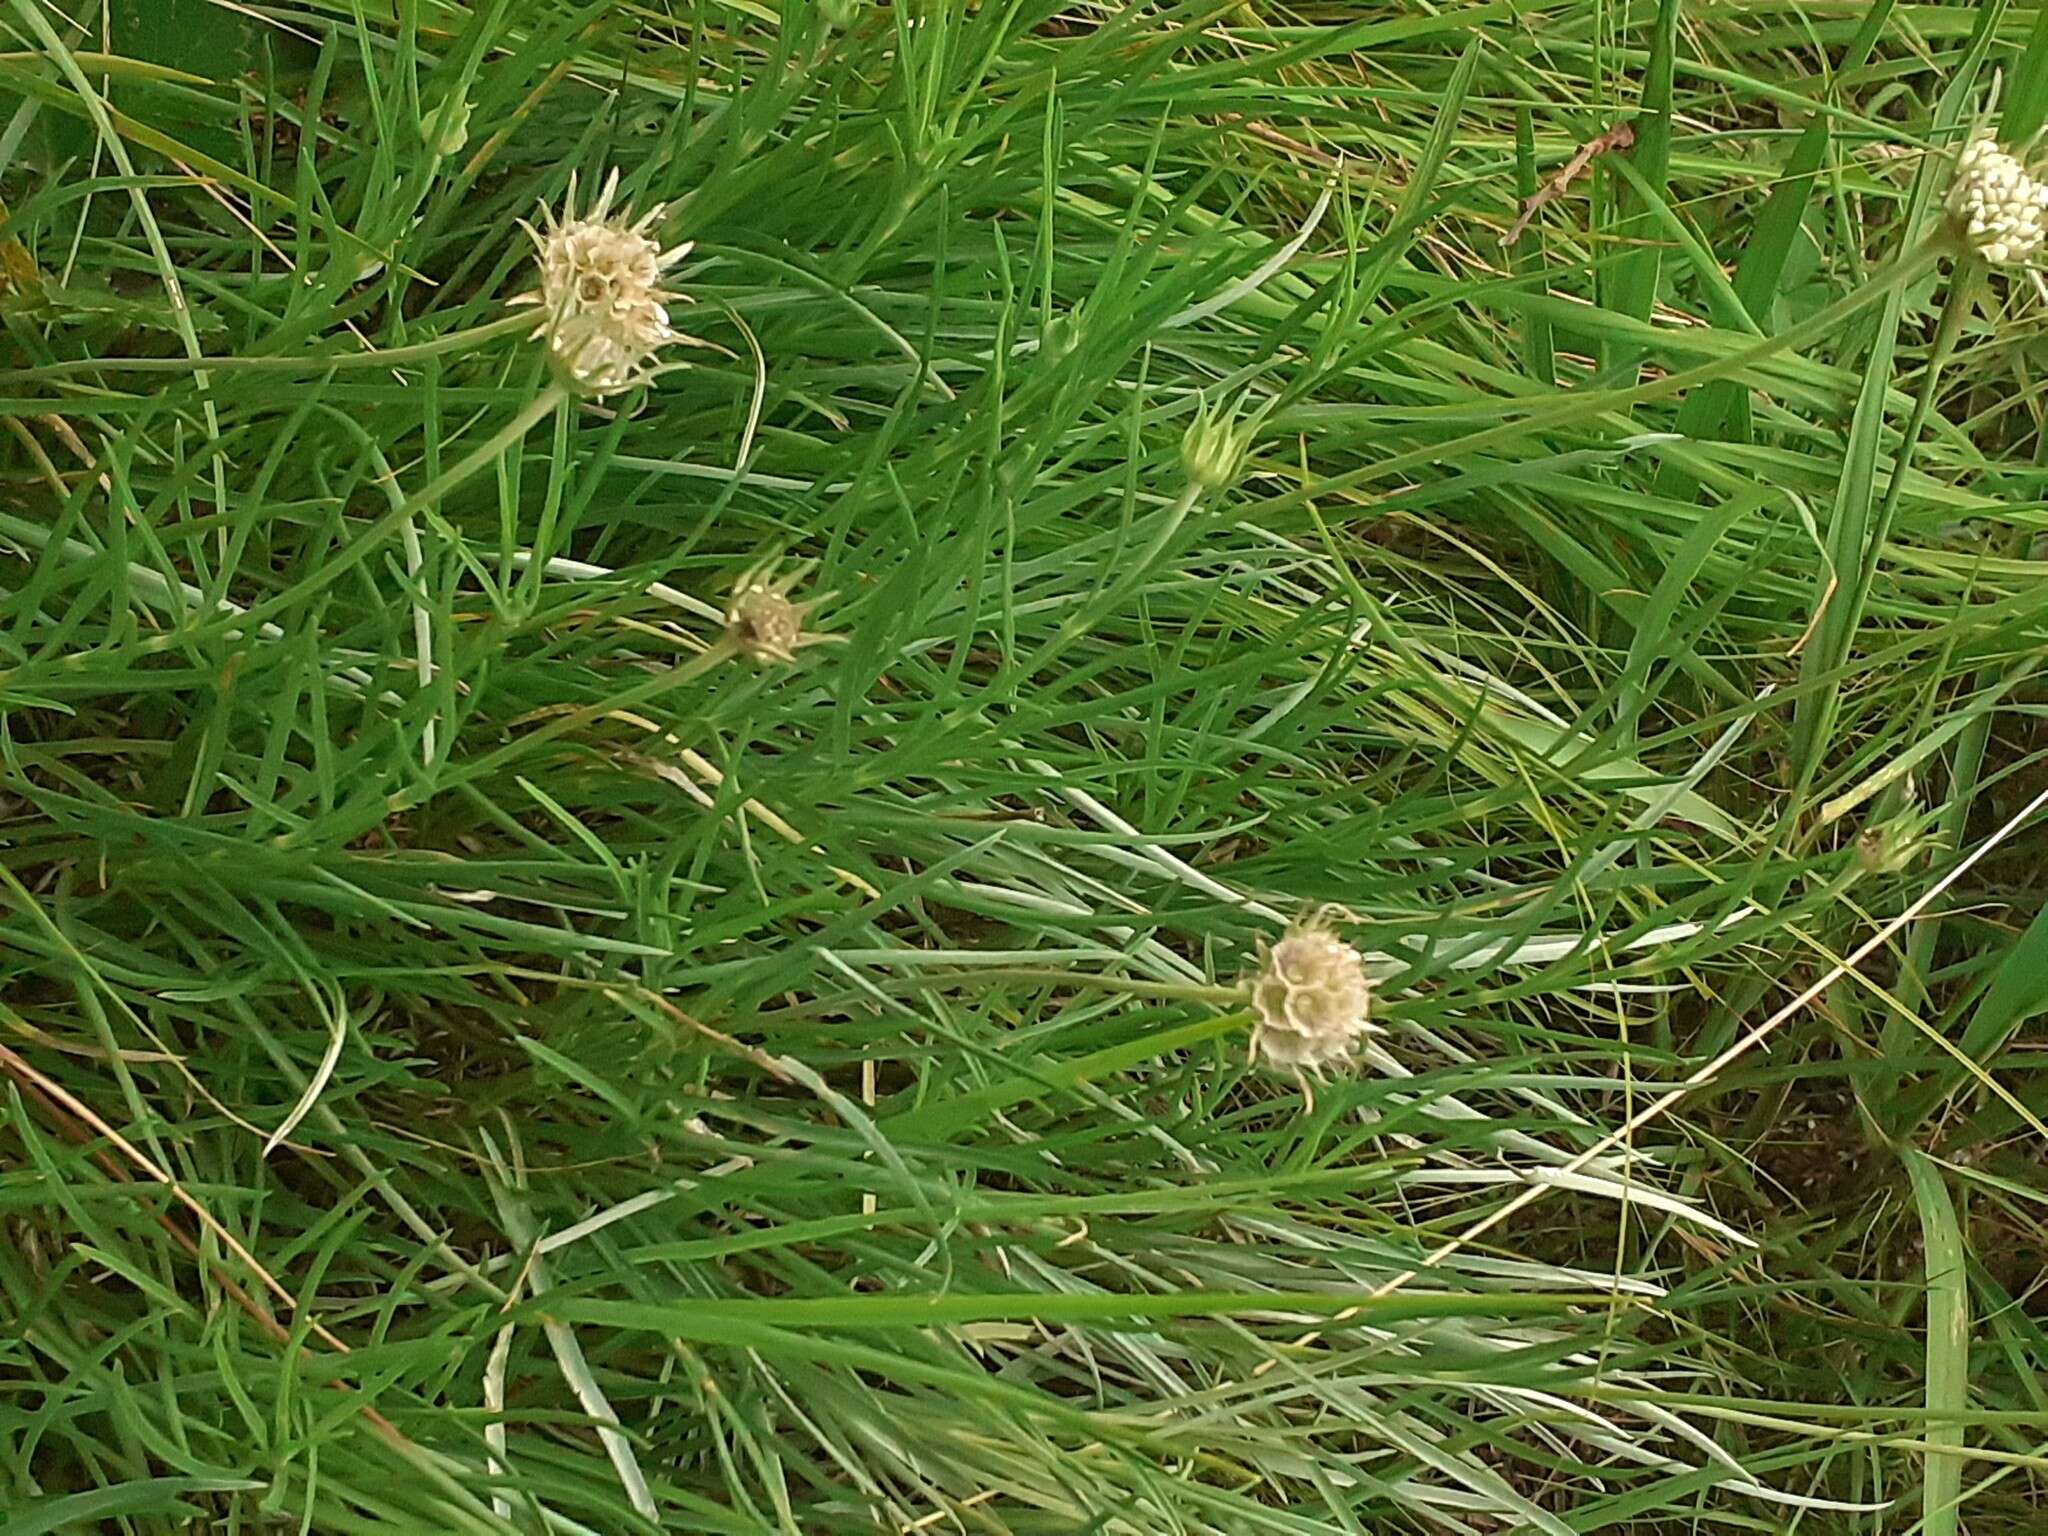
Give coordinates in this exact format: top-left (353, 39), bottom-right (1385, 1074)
top-left (512, 170), bottom-right (694, 395)
